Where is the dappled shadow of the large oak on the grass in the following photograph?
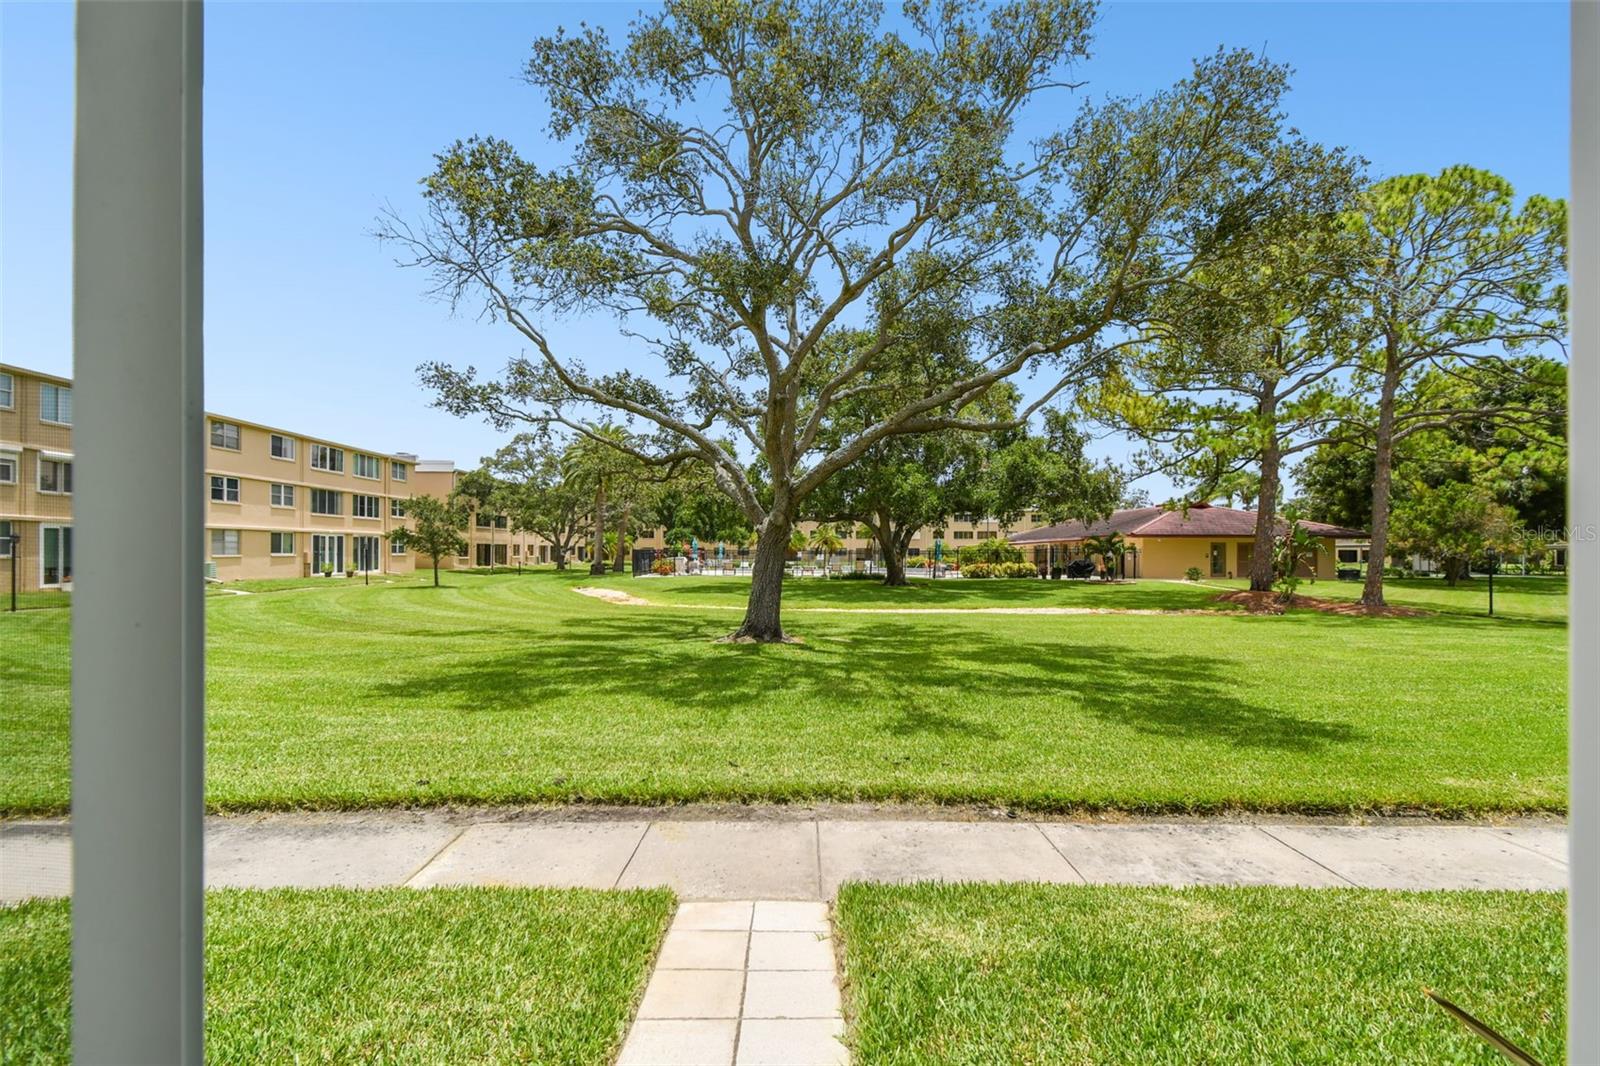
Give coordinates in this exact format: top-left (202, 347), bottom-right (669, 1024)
top-left (370, 611), bottom-right (1365, 752)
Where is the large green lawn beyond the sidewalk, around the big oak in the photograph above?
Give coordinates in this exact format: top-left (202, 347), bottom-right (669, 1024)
top-left (0, 571), bottom-right (1566, 815)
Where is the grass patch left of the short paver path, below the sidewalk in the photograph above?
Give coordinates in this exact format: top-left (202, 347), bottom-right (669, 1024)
top-left (0, 888), bottom-right (674, 1066)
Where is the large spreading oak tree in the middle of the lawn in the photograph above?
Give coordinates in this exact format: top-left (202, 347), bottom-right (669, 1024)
top-left (382, 0), bottom-right (1312, 642)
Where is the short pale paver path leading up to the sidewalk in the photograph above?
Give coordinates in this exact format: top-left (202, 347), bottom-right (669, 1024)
top-left (618, 900), bottom-right (850, 1066)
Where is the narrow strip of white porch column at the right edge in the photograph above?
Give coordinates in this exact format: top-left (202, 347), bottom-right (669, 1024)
top-left (1566, 0), bottom-right (1600, 1063)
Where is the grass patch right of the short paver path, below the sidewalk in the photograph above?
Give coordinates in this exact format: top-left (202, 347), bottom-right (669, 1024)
top-left (838, 884), bottom-right (1566, 1066)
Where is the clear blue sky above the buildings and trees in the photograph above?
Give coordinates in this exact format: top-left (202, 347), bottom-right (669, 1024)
top-left (0, 0), bottom-right (1568, 499)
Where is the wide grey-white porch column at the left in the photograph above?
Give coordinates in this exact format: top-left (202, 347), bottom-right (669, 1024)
top-left (72, 0), bottom-right (205, 1064)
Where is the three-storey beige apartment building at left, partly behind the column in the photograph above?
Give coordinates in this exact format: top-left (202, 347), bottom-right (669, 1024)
top-left (0, 363), bottom-right (416, 592)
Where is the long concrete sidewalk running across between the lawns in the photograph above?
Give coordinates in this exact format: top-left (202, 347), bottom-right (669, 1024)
top-left (0, 808), bottom-right (1566, 903)
